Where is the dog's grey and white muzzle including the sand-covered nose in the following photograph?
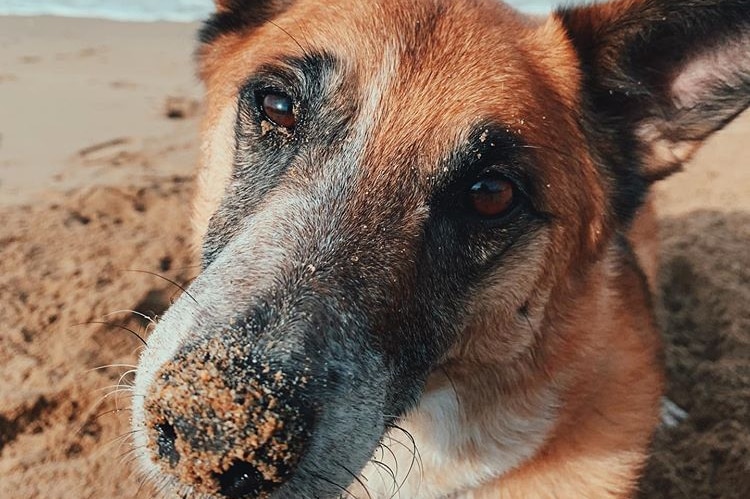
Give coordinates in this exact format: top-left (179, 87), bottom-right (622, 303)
top-left (133, 189), bottom-right (418, 498)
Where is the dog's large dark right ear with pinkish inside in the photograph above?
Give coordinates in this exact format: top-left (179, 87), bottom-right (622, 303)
top-left (557, 0), bottom-right (750, 180)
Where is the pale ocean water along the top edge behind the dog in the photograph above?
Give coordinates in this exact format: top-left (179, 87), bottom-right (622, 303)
top-left (0, 0), bottom-right (570, 22)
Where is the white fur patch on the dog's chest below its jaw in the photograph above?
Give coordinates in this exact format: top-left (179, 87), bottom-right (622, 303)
top-left (351, 385), bottom-right (558, 499)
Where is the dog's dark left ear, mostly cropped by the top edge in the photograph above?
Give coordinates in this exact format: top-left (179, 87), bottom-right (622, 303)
top-left (198, 0), bottom-right (294, 44)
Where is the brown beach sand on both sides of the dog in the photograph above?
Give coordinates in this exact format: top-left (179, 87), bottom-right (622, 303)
top-left (0, 13), bottom-right (750, 498)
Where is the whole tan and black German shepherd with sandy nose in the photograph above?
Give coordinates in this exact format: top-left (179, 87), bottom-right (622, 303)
top-left (133, 0), bottom-right (750, 499)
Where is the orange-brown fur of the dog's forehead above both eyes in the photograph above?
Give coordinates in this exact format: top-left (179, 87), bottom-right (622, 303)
top-left (203, 0), bottom-right (582, 185)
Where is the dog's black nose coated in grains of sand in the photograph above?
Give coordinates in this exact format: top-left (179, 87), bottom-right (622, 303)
top-left (145, 337), bottom-right (312, 498)
